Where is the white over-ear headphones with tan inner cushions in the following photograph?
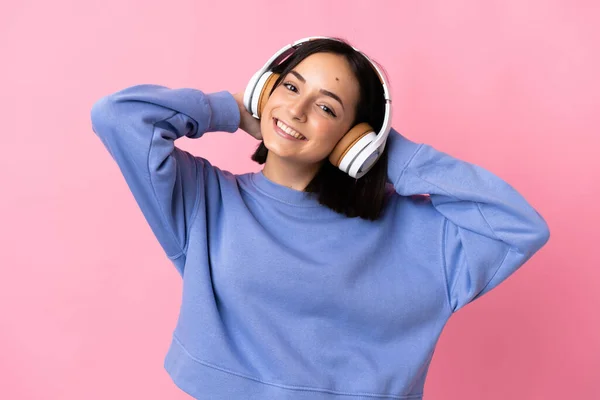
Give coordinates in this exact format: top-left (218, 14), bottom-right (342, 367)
top-left (244, 36), bottom-right (392, 179)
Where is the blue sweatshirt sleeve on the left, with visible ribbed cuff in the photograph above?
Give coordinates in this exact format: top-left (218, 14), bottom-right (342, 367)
top-left (91, 84), bottom-right (240, 273)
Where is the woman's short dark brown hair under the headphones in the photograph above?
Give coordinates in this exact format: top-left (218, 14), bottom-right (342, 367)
top-left (252, 38), bottom-right (388, 220)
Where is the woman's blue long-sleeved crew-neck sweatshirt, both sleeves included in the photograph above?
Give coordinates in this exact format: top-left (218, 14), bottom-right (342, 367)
top-left (91, 85), bottom-right (549, 400)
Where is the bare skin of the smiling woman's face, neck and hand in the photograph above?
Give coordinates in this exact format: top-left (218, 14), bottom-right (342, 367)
top-left (234, 53), bottom-right (360, 191)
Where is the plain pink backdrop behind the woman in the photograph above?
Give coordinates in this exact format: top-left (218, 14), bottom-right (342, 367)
top-left (0, 0), bottom-right (600, 400)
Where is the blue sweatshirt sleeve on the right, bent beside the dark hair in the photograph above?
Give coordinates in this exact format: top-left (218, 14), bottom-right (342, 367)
top-left (387, 129), bottom-right (550, 311)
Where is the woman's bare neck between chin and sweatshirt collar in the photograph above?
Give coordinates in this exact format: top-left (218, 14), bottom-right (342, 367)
top-left (262, 152), bottom-right (320, 191)
